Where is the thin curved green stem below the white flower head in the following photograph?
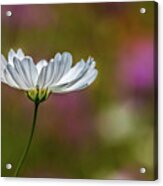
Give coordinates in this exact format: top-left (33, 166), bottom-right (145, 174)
top-left (14, 103), bottom-right (39, 177)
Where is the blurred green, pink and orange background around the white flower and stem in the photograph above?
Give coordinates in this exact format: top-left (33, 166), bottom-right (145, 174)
top-left (1, 2), bottom-right (157, 180)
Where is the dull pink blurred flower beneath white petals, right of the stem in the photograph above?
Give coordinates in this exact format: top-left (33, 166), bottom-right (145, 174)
top-left (54, 92), bottom-right (94, 144)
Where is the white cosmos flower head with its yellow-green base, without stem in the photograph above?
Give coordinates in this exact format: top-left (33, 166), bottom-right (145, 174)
top-left (1, 49), bottom-right (98, 102)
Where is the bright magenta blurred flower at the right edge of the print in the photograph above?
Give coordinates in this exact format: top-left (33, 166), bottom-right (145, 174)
top-left (117, 38), bottom-right (155, 90)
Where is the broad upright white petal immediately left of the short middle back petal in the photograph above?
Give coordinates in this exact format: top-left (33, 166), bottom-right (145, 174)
top-left (20, 57), bottom-right (38, 87)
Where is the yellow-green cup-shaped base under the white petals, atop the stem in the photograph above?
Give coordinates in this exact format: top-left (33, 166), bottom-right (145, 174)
top-left (26, 88), bottom-right (50, 103)
